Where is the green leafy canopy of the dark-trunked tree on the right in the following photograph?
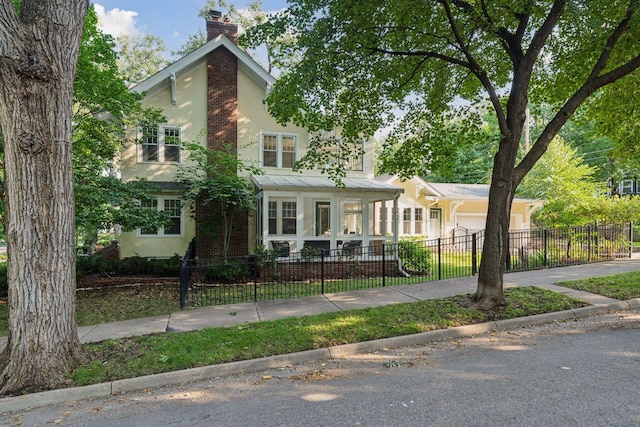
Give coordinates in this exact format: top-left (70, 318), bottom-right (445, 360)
top-left (261, 0), bottom-right (640, 181)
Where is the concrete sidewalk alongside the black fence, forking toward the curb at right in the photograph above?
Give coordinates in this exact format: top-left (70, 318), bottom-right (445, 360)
top-left (76, 257), bottom-right (640, 345)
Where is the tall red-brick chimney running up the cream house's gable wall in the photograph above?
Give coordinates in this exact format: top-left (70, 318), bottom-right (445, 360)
top-left (196, 11), bottom-right (249, 258)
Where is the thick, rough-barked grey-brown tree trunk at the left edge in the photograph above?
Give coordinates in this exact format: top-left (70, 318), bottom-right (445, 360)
top-left (0, 0), bottom-right (88, 394)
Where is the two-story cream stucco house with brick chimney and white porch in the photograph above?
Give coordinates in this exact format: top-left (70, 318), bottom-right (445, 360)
top-left (119, 15), bottom-right (403, 258)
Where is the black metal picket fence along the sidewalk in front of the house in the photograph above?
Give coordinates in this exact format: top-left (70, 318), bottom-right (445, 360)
top-left (180, 223), bottom-right (633, 307)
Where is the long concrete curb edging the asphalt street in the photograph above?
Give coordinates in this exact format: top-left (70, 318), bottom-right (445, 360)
top-left (0, 298), bottom-right (640, 413)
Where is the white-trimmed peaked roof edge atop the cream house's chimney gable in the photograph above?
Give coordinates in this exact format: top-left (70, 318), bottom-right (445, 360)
top-left (131, 35), bottom-right (275, 92)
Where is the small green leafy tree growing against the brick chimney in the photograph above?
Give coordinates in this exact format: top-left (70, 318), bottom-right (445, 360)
top-left (176, 143), bottom-right (262, 257)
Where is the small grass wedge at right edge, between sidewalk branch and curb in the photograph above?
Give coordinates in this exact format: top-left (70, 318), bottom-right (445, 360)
top-left (558, 271), bottom-right (640, 300)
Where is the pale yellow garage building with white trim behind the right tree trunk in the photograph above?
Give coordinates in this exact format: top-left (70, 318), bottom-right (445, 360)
top-left (377, 175), bottom-right (544, 239)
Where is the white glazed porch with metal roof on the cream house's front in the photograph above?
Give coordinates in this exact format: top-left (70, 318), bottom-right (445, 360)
top-left (252, 174), bottom-right (403, 256)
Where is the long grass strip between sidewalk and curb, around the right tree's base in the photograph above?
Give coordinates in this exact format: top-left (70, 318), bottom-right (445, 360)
top-left (72, 287), bottom-right (587, 385)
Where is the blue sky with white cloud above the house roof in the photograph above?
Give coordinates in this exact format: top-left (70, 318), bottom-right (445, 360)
top-left (93, 0), bottom-right (286, 56)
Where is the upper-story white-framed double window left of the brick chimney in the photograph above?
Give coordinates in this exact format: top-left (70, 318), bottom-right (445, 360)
top-left (138, 125), bottom-right (182, 163)
